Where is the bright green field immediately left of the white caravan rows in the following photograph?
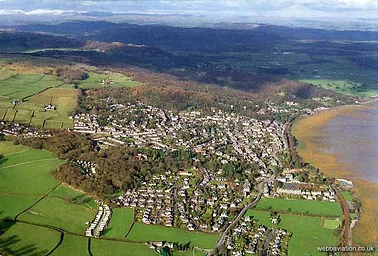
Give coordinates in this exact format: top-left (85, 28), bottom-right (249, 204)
top-left (19, 198), bottom-right (96, 234)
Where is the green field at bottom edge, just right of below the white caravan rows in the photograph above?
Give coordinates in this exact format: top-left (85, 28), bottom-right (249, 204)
top-left (91, 239), bottom-right (157, 256)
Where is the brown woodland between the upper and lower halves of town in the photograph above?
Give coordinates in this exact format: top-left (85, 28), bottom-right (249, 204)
top-left (52, 146), bottom-right (193, 196)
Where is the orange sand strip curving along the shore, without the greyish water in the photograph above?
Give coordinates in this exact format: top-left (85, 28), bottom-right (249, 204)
top-left (290, 104), bottom-right (378, 252)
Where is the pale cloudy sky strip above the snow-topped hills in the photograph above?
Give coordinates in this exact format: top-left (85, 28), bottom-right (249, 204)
top-left (0, 0), bottom-right (378, 19)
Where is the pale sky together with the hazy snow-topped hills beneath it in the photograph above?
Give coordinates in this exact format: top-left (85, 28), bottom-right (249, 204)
top-left (0, 0), bottom-right (378, 30)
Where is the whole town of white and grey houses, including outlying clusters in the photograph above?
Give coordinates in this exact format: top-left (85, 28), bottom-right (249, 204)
top-left (3, 98), bottom-right (348, 256)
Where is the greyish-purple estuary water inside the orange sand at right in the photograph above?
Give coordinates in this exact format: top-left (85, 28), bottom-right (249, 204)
top-left (320, 101), bottom-right (378, 183)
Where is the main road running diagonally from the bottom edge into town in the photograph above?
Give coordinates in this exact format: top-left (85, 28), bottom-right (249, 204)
top-left (208, 177), bottom-right (273, 256)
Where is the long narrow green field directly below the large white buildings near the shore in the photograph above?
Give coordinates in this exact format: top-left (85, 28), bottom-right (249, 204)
top-left (256, 198), bottom-right (342, 216)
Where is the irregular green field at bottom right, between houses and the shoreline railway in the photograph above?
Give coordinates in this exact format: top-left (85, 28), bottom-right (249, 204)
top-left (246, 210), bottom-right (337, 256)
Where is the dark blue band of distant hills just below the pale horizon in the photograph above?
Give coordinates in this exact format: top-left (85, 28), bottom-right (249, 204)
top-left (15, 21), bottom-right (378, 50)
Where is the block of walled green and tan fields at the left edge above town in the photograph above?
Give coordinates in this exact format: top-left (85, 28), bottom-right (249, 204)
top-left (0, 72), bottom-right (78, 128)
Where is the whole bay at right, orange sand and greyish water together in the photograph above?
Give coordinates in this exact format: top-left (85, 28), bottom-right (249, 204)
top-left (292, 101), bottom-right (378, 250)
